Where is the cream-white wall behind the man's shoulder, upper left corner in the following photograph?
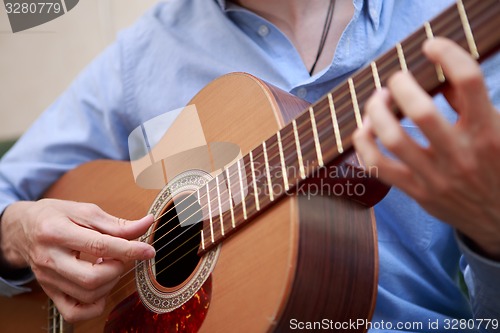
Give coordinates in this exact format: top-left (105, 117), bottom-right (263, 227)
top-left (0, 0), bottom-right (158, 140)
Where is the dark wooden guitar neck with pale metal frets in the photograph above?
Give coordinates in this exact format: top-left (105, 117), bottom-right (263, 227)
top-left (197, 0), bottom-right (500, 254)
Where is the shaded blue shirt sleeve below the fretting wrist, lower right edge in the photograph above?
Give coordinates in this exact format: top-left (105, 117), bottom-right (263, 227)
top-left (457, 233), bottom-right (500, 332)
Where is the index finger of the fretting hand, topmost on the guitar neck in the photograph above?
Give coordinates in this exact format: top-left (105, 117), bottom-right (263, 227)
top-left (423, 37), bottom-right (494, 127)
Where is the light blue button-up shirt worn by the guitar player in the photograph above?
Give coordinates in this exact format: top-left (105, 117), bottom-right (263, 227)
top-left (0, 0), bottom-right (500, 332)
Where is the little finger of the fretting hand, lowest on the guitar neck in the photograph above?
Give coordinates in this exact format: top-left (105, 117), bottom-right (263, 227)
top-left (353, 118), bottom-right (420, 197)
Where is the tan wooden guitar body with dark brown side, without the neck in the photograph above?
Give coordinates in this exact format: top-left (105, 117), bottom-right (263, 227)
top-left (0, 73), bottom-right (377, 332)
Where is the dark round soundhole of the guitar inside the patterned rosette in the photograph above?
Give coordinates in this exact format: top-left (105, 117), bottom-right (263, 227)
top-left (152, 194), bottom-right (203, 288)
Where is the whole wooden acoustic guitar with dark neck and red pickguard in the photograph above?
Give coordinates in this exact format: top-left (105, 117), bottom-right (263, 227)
top-left (0, 0), bottom-right (500, 332)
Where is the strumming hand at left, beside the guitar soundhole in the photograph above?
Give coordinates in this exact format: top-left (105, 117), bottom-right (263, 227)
top-left (1, 199), bottom-right (155, 322)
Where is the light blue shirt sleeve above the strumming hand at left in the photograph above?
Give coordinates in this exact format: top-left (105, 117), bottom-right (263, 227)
top-left (0, 37), bottom-right (129, 296)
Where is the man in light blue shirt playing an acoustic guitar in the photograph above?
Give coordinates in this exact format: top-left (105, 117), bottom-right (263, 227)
top-left (0, 0), bottom-right (500, 331)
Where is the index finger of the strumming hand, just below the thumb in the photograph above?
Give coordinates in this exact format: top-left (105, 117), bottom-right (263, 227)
top-left (59, 223), bottom-right (155, 262)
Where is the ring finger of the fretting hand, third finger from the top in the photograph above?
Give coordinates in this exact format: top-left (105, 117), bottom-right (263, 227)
top-left (366, 89), bottom-right (435, 177)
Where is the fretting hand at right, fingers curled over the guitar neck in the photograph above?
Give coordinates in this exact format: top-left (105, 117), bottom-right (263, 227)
top-left (354, 38), bottom-right (500, 260)
